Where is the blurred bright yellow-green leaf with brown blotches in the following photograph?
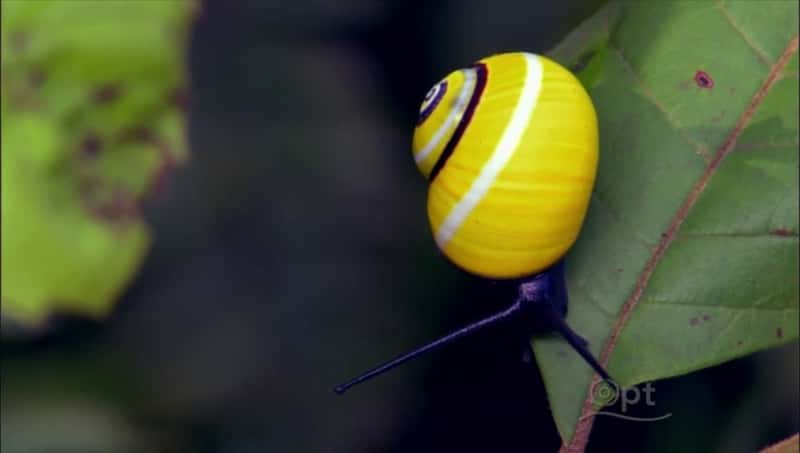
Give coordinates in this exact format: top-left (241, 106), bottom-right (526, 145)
top-left (0, 0), bottom-right (194, 324)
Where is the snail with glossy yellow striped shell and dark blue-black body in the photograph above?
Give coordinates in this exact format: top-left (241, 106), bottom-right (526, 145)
top-left (334, 52), bottom-right (610, 394)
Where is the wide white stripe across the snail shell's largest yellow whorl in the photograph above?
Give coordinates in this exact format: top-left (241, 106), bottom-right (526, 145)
top-left (436, 54), bottom-right (542, 249)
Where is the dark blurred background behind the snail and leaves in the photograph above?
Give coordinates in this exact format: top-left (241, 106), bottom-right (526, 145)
top-left (2, 0), bottom-right (800, 453)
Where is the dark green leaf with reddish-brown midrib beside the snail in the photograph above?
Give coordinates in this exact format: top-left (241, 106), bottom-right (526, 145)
top-left (533, 1), bottom-right (798, 444)
